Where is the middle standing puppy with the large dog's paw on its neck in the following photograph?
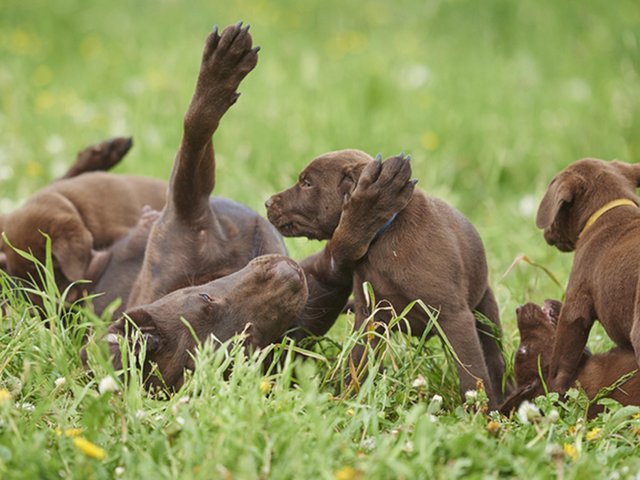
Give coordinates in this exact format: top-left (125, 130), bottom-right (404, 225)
top-left (266, 150), bottom-right (504, 407)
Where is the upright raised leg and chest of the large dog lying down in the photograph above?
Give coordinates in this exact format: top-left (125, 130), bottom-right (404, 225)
top-left (128, 24), bottom-right (286, 307)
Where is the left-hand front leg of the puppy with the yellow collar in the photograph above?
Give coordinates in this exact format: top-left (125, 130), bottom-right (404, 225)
top-left (549, 296), bottom-right (595, 394)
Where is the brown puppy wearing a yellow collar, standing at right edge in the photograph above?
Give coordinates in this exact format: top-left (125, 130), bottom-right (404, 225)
top-left (536, 158), bottom-right (640, 393)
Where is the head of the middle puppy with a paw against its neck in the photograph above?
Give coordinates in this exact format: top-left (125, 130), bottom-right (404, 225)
top-left (265, 150), bottom-right (373, 240)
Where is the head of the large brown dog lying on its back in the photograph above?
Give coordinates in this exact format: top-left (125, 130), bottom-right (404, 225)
top-left (107, 255), bottom-right (307, 389)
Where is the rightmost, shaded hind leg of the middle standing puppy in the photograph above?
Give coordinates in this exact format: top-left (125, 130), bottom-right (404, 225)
top-left (475, 287), bottom-right (512, 402)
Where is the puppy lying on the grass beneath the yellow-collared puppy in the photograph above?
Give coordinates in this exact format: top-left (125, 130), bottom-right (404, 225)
top-left (500, 300), bottom-right (640, 417)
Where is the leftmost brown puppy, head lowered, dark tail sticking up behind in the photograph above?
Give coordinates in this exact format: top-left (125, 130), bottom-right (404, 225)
top-left (0, 133), bottom-right (166, 296)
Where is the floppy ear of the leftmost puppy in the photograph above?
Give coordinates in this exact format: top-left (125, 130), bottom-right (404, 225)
top-left (51, 224), bottom-right (93, 282)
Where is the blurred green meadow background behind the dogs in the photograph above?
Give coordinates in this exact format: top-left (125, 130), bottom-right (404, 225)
top-left (0, 0), bottom-right (640, 344)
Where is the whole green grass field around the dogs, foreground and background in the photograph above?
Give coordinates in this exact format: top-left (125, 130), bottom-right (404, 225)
top-left (0, 0), bottom-right (640, 480)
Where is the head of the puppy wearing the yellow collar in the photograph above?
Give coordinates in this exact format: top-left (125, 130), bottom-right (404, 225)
top-left (536, 158), bottom-right (640, 252)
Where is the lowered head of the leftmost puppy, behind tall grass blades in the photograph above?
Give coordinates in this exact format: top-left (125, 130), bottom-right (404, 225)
top-left (3, 195), bottom-right (93, 290)
